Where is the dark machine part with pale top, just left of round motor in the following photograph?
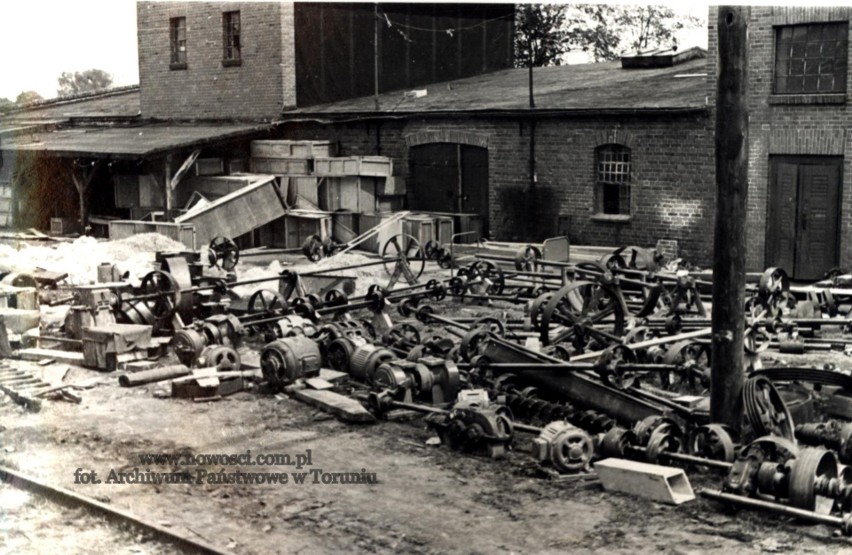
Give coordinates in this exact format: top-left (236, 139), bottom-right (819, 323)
top-left (427, 390), bottom-right (514, 458)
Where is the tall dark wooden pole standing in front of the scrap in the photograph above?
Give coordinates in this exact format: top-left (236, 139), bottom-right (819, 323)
top-left (710, 6), bottom-right (749, 430)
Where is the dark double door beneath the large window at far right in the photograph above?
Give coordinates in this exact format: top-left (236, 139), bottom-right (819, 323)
top-left (767, 156), bottom-right (842, 279)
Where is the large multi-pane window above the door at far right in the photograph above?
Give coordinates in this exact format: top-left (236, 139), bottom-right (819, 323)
top-left (774, 22), bottom-right (849, 94)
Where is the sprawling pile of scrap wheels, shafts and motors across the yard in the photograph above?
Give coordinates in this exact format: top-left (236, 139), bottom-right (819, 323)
top-left (5, 235), bottom-right (852, 535)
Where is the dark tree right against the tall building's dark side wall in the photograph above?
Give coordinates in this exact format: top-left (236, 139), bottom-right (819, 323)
top-left (515, 4), bottom-right (569, 67)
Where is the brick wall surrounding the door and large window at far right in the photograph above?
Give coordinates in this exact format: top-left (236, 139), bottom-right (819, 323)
top-left (707, 6), bottom-right (852, 271)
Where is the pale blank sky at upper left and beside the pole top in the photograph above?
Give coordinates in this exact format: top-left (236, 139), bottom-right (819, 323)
top-left (0, 0), bottom-right (707, 100)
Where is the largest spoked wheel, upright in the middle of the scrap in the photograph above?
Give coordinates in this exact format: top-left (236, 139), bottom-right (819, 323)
top-left (539, 281), bottom-right (627, 350)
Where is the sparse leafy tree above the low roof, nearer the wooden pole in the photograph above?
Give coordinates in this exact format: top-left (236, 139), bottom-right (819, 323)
top-left (567, 4), bottom-right (702, 62)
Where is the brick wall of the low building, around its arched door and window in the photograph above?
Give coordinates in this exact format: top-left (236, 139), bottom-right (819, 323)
top-left (280, 111), bottom-right (715, 266)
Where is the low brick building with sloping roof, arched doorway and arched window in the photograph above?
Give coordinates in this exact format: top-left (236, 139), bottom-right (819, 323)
top-left (278, 50), bottom-right (715, 264)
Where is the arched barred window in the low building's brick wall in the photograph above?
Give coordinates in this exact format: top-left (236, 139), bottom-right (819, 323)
top-left (595, 145), bottom-right (630, 214)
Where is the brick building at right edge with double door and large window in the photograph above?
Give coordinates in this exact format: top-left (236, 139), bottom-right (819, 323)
top-left (708, 6), bottom-right (852, 279)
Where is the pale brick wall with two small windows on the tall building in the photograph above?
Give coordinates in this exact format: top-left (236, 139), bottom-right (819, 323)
top-left (137, 2), bottom-right (296, 120)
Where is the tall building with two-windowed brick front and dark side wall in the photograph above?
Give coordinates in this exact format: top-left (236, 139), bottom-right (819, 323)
top-left (137, 1), bottom-right (514, 120)
